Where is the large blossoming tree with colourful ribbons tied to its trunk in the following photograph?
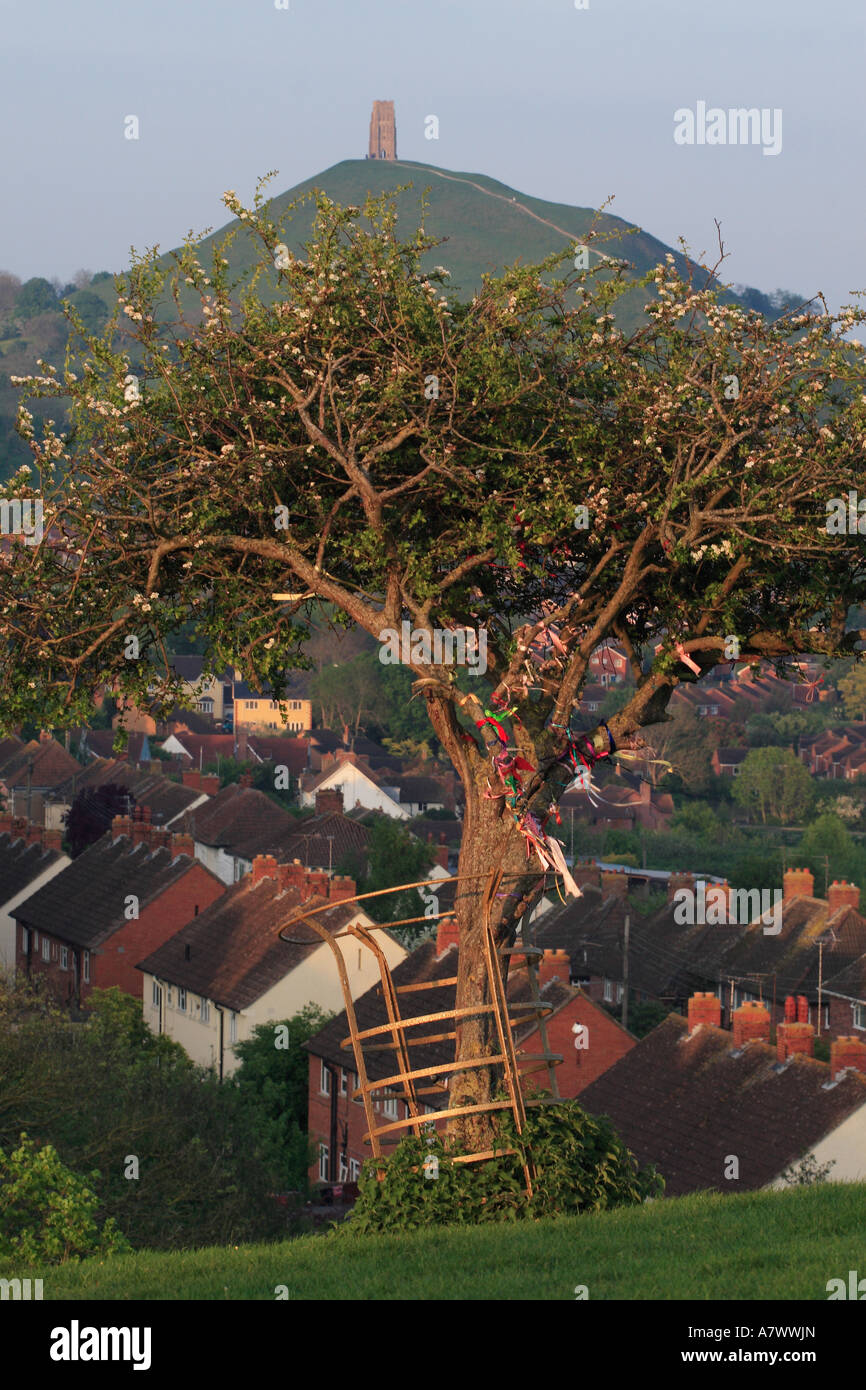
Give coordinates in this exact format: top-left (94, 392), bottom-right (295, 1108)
top-left (0, 189), bottom-right (866, 1148)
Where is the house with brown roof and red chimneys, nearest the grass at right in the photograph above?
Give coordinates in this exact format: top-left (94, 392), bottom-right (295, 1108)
top-left (581, 994), bottom-right (866, 1197)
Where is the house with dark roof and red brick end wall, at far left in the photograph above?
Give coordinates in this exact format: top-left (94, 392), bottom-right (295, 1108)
top-left (10, 816), bottom-right (225, 1006)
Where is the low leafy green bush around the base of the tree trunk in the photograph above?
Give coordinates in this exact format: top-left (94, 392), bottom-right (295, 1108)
top-left (341, 1101), bottom-right (663, 1234)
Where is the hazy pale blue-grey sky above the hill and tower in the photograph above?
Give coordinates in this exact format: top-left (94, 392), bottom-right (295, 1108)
top-left (0, 0), bottom-right (866, 307)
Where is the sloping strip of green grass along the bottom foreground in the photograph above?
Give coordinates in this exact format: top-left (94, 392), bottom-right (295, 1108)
top-left (11, 1183), bottom-right (866, 1301)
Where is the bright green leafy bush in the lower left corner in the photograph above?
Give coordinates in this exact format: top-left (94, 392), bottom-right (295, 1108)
top-left (0, 1134), bottom-right (131, 1264)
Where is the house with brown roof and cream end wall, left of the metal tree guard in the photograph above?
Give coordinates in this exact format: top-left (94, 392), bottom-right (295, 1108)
top-left (138, 855), bottom-right (406, 1079)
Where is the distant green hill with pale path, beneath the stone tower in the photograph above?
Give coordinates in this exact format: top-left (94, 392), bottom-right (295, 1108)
top-left (0, 160), bottom-right (799, 477)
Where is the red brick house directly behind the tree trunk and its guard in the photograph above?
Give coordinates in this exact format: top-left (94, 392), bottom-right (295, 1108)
top-left (304, 919), bottom-right (635, 1182)
